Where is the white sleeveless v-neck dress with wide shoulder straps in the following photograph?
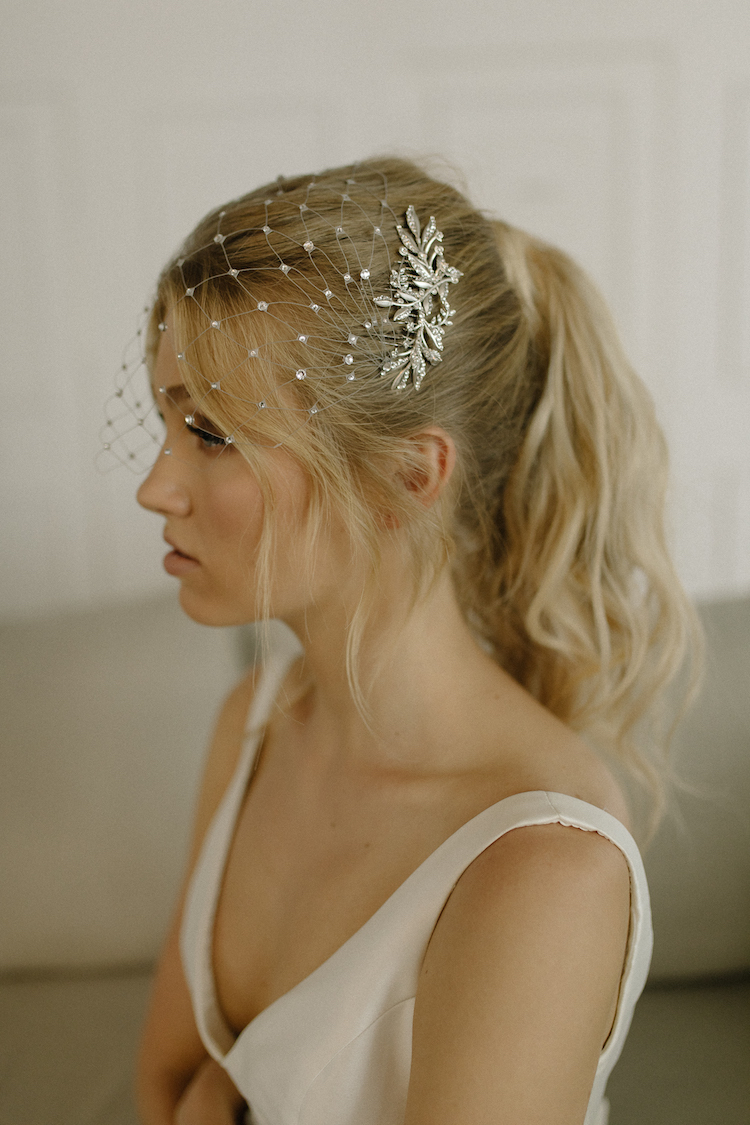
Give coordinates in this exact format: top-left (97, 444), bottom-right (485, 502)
top-left (180, 625), bottom-right (652, 1125)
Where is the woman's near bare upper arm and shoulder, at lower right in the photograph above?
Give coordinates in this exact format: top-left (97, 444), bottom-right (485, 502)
top-left (405, 825), bottom-right (630, 1125)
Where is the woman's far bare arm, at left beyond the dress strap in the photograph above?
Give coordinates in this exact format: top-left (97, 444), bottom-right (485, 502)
top-left (136, 672), bottom-right (259, 1125)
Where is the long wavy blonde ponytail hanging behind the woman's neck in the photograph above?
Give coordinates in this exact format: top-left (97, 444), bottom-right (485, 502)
top-left (463, 223), bottom-right (701, 819)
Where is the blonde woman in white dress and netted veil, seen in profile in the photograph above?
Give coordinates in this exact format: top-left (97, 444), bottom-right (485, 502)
top-left (127, 159), bottom-right (693, 1125)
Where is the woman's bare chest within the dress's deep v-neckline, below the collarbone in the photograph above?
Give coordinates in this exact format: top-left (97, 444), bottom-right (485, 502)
top-left (213, 747), bottom-right (481, 1032)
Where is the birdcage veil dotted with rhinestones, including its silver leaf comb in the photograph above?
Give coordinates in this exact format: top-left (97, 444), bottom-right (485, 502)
top-left (100, 177), bottom-right (461, 471)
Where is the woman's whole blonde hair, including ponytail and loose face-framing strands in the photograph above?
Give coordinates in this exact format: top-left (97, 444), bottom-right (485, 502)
top-left (148, 158), bottom-right (699, 819)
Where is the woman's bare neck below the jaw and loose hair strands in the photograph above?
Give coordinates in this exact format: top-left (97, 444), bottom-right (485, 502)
top-left (277, 563), bottom-right (504, 768)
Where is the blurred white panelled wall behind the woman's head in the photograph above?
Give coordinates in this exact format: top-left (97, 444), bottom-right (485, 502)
top-left (0, 0), bottom-right (750, 618)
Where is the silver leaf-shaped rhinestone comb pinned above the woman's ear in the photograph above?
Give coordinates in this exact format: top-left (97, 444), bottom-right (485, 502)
top-left (374, 206), bottom-right (463, 390)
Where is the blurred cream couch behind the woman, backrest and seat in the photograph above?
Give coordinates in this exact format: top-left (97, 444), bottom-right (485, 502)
top-left (0, 600), bottom-right (750, 1125)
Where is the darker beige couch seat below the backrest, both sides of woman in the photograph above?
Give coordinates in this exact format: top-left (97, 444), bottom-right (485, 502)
top-left (0, 973), bottom-right (750, 1125)
